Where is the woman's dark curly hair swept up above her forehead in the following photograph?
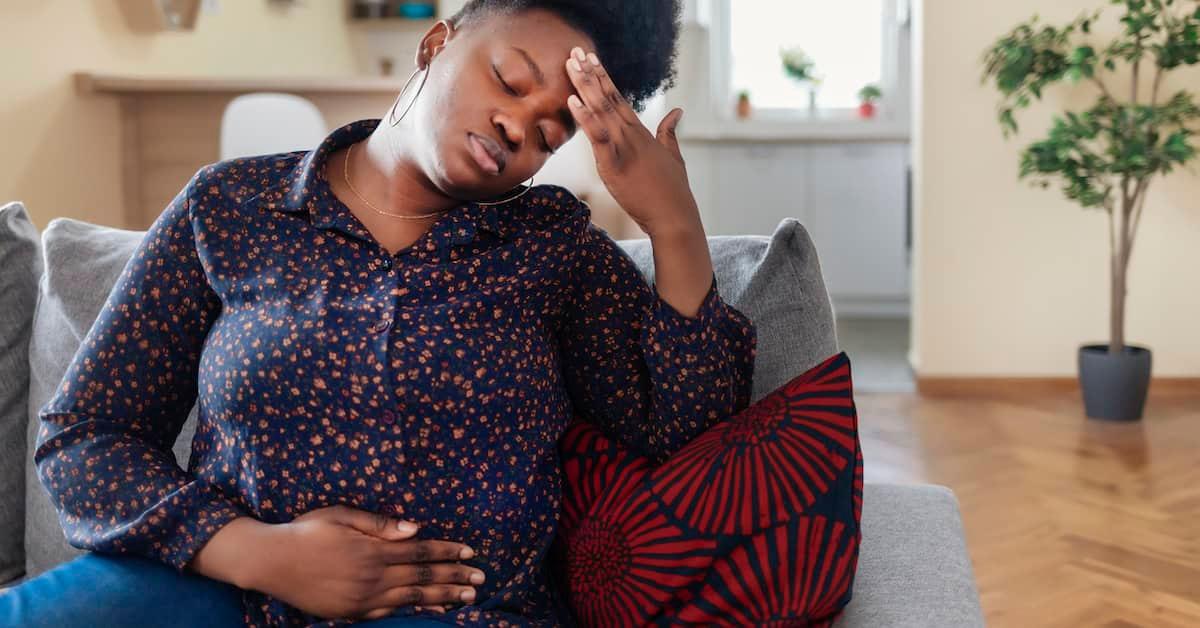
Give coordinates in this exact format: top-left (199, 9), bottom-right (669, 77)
top-left (450, 0), bottom-right (680, 113)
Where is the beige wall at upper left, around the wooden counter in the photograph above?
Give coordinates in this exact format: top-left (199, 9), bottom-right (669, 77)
top-left (0, 0), bottom-right (429, 228)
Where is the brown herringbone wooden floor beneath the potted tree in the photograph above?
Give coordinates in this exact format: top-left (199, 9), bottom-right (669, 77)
top-left (856, 391), bottom-right (1200, 628)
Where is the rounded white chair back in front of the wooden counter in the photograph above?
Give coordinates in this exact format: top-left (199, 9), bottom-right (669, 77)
top-left (221, 91), bottom-right (329, 160)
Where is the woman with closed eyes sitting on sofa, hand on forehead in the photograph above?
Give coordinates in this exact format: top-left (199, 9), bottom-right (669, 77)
top-left (5, 0), bottom-right (755, 626)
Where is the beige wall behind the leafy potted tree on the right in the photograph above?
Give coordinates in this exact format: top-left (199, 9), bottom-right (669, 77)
top-left (912, 0), bottom-right (1200, 377)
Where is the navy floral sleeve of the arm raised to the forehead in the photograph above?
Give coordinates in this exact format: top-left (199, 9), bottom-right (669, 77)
top-left (559, 222), bottom-right (756, 462)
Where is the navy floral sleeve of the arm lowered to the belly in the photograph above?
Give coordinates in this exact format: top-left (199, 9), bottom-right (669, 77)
top-left (34, 169), bottom-right (246, 573)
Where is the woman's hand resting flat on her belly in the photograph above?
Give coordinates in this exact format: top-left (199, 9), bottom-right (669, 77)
top-left (251, 504), bottom-right (484, 620)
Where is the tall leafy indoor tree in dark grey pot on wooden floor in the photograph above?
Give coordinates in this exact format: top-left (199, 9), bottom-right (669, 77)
top-left (983, 0), bottom-right (1200, 420)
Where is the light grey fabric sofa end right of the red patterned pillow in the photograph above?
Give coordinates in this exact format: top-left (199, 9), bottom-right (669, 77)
top-left (834, 483), bottom-right (984, 628)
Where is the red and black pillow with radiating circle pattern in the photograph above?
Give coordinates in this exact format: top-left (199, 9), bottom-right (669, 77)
top-left (551, 352), bottom-right (863, 627)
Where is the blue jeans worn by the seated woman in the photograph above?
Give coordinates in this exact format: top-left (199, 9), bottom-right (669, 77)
top-left (0, 552), bottom-right (448, 628)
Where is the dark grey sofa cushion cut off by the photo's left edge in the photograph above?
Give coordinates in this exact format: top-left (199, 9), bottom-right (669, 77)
top-left (0, 202), bottom-right (42, 584)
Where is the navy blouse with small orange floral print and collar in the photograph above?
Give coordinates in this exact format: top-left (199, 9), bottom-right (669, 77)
top-left (34, 119), bottom-right (755, 626)
